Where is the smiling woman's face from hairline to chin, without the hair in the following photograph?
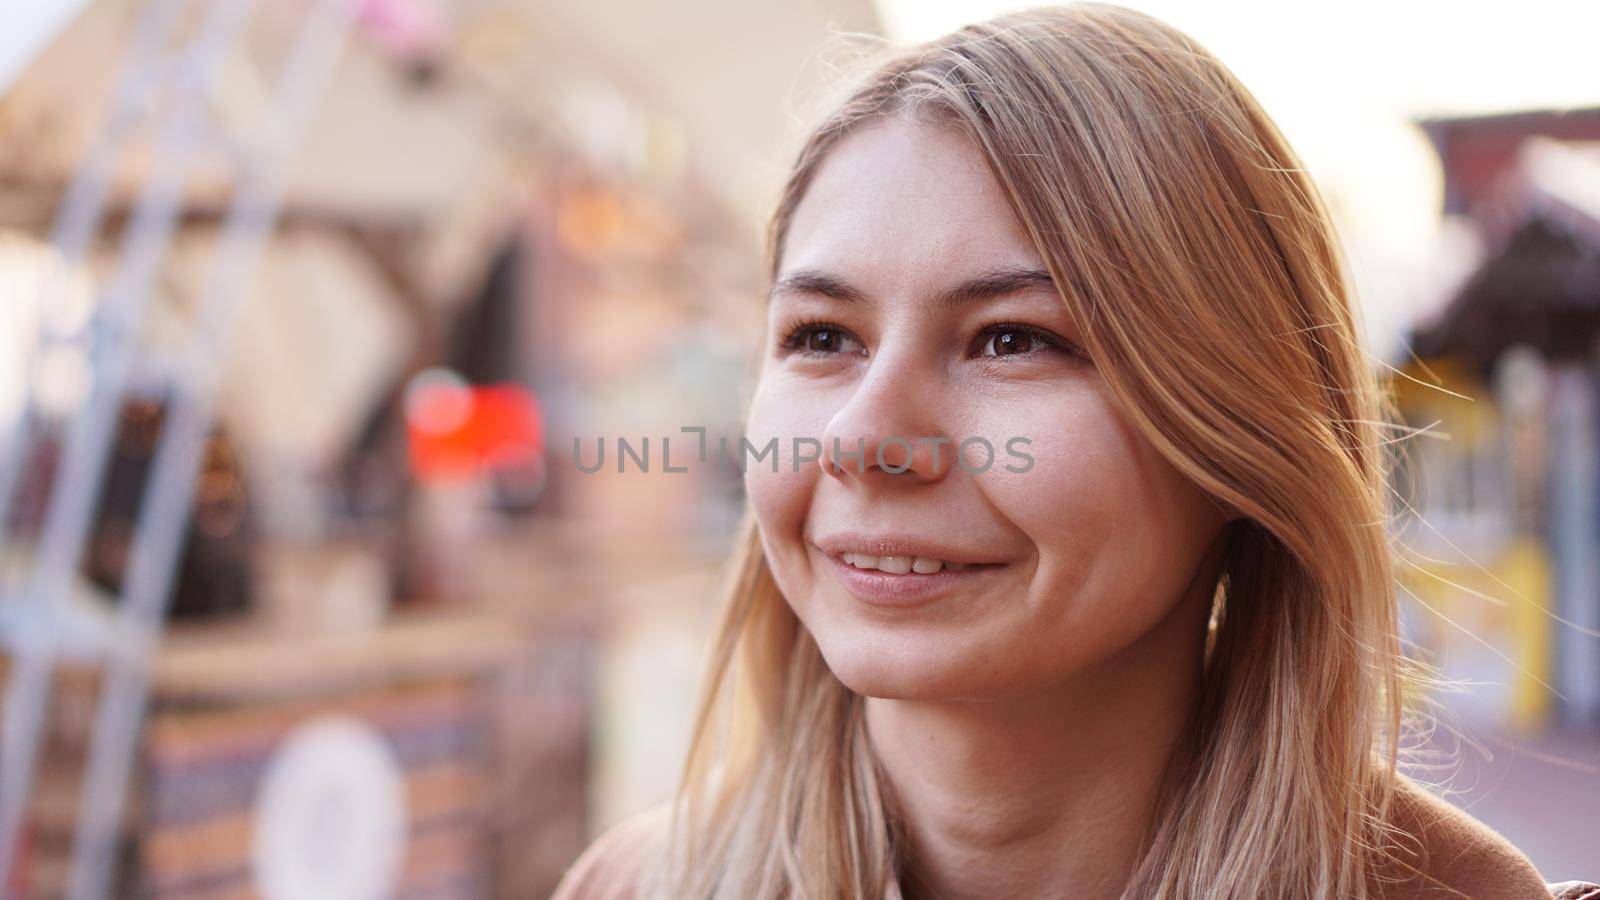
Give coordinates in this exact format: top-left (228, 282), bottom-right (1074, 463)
top-left (746, 119), bottom-right (1224, 698)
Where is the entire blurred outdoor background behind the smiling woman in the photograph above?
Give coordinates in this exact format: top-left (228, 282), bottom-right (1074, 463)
top-left (0, 0), bottom-right (1600, 898)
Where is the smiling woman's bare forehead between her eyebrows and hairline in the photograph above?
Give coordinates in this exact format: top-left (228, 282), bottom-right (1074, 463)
top-left (782, 117), bottom-right (1040, 283)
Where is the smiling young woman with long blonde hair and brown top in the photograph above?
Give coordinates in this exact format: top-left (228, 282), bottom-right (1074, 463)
top-left (557, 3), bottom-right (1587, 900)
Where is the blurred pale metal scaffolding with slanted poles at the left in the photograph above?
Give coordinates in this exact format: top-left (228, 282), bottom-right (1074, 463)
top-left (0, 0), bottom-right (355, 900)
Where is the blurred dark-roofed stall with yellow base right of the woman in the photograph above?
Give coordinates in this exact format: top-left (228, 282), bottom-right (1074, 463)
top-left (1395, 109), bottom-right (1600, 732)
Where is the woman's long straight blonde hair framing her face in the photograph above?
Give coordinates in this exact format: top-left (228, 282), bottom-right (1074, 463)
top-left (661, 3), bottom-right (1422, 900)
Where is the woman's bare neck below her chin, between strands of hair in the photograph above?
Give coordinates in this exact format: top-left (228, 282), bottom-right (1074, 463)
top-left (866, 557), bottom-right (1210, 900)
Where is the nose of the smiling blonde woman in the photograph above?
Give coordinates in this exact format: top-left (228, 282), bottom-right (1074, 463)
top-left (818, 342), bottom-right (955, 482)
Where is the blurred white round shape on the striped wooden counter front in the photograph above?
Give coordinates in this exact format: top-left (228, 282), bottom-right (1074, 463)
top-left (251, 714), bottom-right (406, 900)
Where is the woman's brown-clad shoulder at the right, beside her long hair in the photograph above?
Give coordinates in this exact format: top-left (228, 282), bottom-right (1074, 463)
top-left (1378, 775), bottom-right (1550, 900)
